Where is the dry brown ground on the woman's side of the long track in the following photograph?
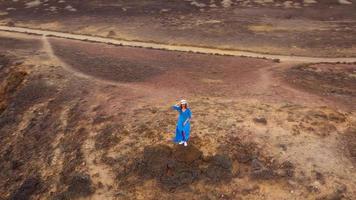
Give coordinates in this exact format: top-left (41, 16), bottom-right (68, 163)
top-left (0, 27), bottom-right (356, 199)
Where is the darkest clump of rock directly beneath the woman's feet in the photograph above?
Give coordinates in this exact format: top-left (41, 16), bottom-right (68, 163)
top-left (129, 145), bottom-right (232, 190)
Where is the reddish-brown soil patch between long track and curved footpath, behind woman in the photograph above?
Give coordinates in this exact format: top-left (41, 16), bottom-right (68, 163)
top-left (50, 39), bottom-right (275, 96)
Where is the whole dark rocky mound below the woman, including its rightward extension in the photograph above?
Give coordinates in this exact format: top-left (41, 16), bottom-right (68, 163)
top-left (118, 142), bottom-right (294, 190)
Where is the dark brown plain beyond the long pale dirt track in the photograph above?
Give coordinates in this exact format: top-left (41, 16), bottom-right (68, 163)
top-left (0, 0), bottom-right (356, 57)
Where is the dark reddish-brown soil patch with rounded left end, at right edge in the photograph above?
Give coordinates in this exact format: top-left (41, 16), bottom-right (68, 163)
top-left (285, 64), bottom-right (356, 110)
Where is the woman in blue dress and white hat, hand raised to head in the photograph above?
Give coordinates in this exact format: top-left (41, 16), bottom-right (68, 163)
top-left (172, 99), bottom-right (192, 146)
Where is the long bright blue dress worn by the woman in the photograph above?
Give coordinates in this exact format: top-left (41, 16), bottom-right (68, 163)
top-left (172, 106), bottom-right (192, 143)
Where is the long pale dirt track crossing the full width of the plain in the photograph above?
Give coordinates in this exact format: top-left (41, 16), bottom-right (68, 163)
top-left (0, 26), bottom-right (356, 63)
